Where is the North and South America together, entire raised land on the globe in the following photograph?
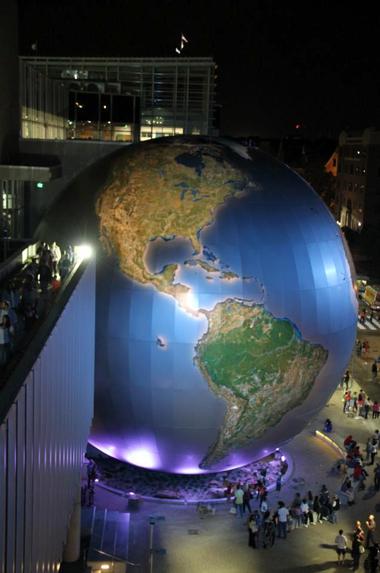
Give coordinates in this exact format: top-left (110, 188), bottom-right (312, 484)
top-left (96, 142), bottom-right (328, 470)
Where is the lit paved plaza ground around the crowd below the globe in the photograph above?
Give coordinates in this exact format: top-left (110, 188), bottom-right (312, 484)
top-left (87, 337), bottom-right (380, 573)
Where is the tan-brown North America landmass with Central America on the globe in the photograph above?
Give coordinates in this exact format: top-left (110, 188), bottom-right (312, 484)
top-left (96, 143), bottom-right (248, 313)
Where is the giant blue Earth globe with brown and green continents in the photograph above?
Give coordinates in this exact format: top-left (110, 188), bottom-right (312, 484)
top-left (39, 137), bottom-right (357, 474)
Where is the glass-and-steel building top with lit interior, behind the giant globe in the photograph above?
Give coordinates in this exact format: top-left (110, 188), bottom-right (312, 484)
top-left (20, 57), bottom-right (216, 142)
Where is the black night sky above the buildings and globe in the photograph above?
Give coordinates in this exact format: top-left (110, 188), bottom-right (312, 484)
top-left (19, 0), bottom-right (380, 137)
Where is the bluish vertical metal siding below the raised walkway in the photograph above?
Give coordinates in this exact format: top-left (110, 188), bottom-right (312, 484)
top-left (0, 263), bottom-right (95, 573)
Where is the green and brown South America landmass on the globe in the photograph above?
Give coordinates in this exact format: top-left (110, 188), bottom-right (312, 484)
top-left (195, 299), bottom-right (328, 468)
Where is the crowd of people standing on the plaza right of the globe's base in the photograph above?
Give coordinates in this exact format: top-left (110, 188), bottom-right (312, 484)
top-left (221, 371), bottom-right (380, 573)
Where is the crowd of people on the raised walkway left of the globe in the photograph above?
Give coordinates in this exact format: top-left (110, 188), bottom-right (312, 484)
top-left (0, 242), bottom-right (75, 366)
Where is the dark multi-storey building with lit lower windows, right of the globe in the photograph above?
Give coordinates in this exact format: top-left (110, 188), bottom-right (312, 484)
top-left (335, 128), bottom-right (380, 231)
